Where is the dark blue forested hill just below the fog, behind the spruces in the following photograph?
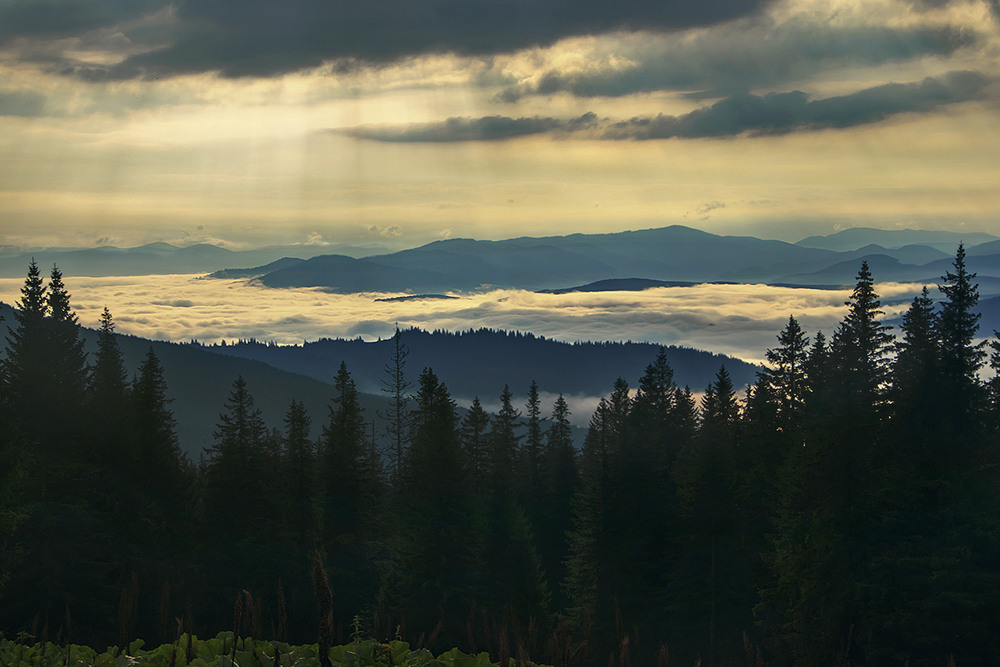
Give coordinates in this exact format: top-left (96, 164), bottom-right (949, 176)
top-left (199, 329), bottom-right (757, 404)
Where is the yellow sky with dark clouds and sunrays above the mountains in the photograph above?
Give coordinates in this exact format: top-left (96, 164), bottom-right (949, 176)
top-left (0, 0), bottom-right (1000, 249)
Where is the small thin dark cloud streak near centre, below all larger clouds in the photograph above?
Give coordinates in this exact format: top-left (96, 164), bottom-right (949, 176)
top-left (343, 113), bottom-right (598, 143)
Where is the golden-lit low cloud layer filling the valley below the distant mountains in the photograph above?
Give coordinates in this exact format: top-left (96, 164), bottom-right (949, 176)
top-left (0, 276), bottom-right (920, 362)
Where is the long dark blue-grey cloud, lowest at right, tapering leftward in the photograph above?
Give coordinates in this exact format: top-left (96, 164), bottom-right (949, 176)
top-left (603, 72), bottom-right (990, 139)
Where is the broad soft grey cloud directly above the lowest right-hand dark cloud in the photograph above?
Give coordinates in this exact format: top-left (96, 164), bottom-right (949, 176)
top-left (499, 20), bottom-right (978, 102)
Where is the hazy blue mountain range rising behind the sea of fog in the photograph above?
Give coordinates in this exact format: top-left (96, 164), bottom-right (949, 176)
top-left (212, 225), bottom-right (1000, 294)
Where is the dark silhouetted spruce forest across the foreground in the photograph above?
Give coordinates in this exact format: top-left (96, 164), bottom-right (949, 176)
top-left (0, 247), bottom-right (1000, 667)
